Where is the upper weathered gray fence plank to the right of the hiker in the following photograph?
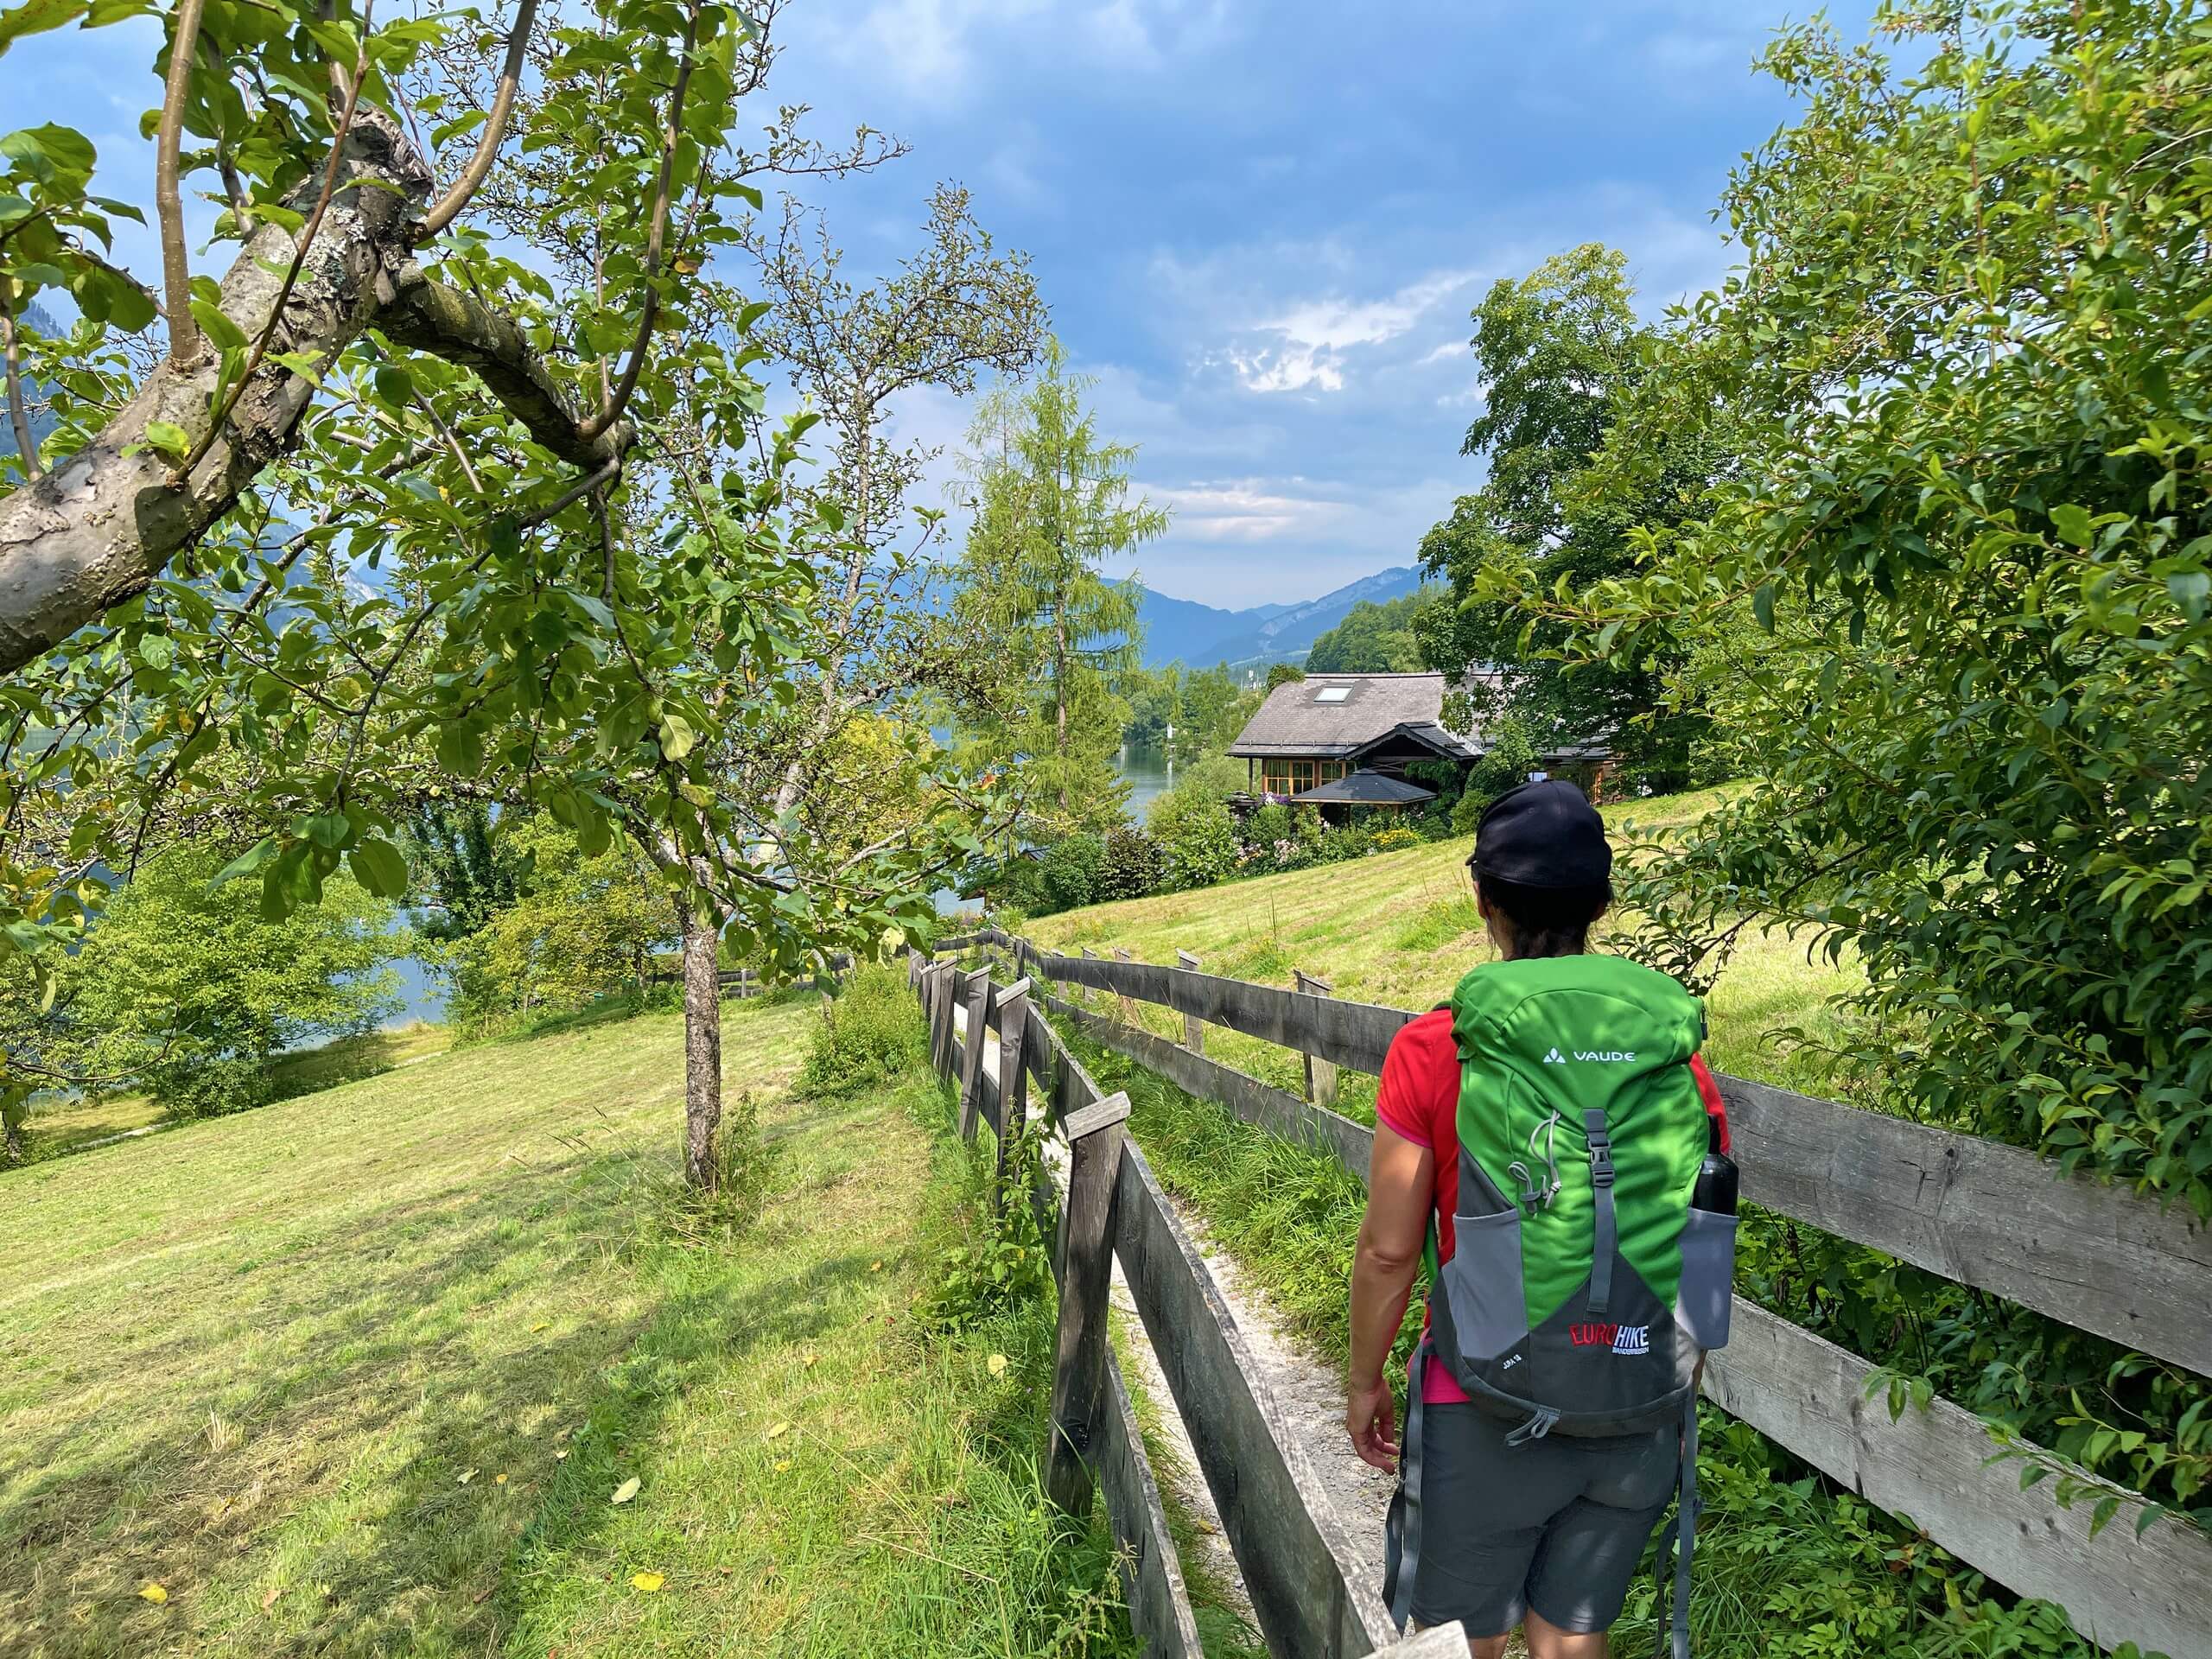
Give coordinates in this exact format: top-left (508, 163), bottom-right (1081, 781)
top-left (1721, 1077), bottom-right (2212, 1376)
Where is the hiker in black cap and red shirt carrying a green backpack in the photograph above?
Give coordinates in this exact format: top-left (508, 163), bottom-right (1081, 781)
top-left (1344, 779), bottom-right (1737, 1659)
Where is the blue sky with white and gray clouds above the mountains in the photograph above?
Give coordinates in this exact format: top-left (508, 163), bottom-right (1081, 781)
top-left (0, 0), bottom-right (1869, 608)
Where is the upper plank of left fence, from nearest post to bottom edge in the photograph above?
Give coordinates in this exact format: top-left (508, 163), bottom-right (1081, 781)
top-left (1115, 1141), bottom-right (1395, 1659)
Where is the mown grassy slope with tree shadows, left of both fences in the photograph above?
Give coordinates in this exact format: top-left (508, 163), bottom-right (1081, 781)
top-left (0, 1004), bottom-right (1126, 1659)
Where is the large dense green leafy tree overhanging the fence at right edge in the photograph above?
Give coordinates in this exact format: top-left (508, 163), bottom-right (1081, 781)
top-left (1489, 0), bottom-right (2212, 1214)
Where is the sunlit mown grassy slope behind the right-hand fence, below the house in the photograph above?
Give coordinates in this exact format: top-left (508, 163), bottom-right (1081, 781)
top-left (1024, 790), bottom-right (1853, 1115)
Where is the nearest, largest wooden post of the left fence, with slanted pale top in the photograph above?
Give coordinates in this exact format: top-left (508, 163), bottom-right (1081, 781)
top-left (1044, 1095), bottom-right (1128, 1516)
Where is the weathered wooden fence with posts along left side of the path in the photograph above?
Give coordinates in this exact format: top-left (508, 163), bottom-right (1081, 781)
top-left (907, 956), bottom-right (1466, 1659)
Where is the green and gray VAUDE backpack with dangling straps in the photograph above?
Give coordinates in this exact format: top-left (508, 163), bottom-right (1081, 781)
top-left (1385, 956), bottom-right (1737, 1655)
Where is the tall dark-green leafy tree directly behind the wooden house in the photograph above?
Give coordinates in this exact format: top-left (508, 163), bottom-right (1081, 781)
top-left (1415, 244), bottom-right (1719, 787)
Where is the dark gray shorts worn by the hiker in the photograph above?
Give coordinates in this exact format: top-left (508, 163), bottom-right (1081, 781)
top-left (1414, 1405), bottom-right (1681, 1637)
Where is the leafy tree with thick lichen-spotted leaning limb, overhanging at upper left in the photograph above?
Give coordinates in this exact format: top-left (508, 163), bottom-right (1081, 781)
top-left (0, 0), bottom-right (995, 1185)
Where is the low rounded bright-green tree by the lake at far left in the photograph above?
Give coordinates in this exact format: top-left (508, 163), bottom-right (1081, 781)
top-left (40, 847), bottom-right (407, 1117)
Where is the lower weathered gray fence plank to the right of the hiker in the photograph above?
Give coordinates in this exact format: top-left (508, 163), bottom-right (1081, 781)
top-left (1706, 1296), bottom-right (2212, 1659)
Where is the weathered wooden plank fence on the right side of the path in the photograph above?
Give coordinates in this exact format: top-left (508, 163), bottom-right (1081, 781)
top-left (940, 929), bottom-right (2212, 1659)
